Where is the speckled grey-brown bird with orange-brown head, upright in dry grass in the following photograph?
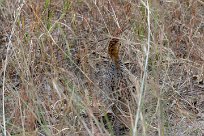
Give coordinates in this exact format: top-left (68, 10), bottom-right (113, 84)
top-left (96, 37), bottom-right (135, 136)
